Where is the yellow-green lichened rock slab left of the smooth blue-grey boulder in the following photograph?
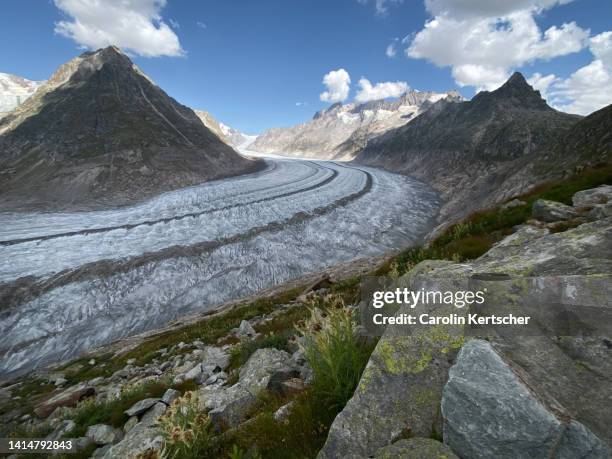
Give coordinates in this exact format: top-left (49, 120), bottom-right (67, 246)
top-left (318, 261), bottom-right (471, 459)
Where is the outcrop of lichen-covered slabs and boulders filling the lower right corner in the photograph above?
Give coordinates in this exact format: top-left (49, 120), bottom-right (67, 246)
top-left (319, 186), bottom-right (612, 459)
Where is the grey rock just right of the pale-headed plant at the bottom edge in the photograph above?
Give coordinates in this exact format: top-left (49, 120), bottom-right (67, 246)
top-left (200, 383), bottom-right (257, 430)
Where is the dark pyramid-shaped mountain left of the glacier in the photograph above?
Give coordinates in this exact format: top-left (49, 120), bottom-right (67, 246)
top-left (0, 46), bottom-right (261, 209)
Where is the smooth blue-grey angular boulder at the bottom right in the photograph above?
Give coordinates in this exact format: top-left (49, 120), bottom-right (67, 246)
top-left (441, 340), bottom-right (612, 459)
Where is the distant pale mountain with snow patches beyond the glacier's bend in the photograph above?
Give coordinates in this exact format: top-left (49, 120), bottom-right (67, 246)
top-left (250, 90), bottom-right (461, 159)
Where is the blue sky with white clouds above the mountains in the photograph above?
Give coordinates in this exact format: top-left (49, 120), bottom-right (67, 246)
top-left (0, 0), bottom-right (612, 134)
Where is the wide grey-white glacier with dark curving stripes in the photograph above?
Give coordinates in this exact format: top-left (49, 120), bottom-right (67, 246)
top-left (0, 159), bottom-right (438, 375)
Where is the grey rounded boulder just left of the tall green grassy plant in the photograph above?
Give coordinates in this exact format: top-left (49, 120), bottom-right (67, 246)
top-left (239, 348), bottom-right (295, 395)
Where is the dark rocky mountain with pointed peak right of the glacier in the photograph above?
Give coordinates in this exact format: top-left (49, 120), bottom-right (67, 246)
top-left (356, 73), bottom-right (580, 218)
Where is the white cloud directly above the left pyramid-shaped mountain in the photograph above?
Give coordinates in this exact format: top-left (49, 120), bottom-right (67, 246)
top-left (54, 0), bottom-right (184, 57)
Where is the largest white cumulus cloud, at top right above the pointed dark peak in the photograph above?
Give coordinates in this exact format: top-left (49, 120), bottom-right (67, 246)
top-left (405, 0), bottom-right (589, 90)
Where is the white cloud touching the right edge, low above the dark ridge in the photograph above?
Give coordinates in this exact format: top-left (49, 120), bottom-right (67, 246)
top-left (549, 31), bottom-right (612, 115)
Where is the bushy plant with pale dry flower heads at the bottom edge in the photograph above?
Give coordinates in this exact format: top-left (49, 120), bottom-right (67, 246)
top-left (160, 392), bottom-right (212, 459)
